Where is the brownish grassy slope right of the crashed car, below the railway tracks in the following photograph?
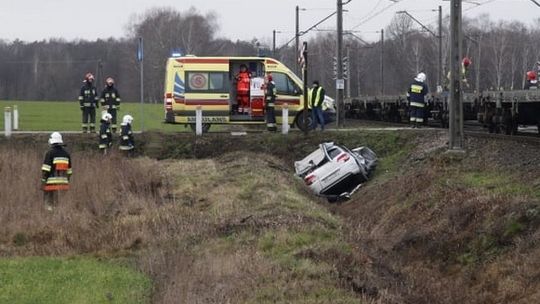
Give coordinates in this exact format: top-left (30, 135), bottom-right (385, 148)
top-left (337, 134), bottom-right (540, 303)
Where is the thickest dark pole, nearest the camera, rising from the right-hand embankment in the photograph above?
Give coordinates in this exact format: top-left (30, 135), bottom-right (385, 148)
top-left (449, 0), bottom-right (464, 151)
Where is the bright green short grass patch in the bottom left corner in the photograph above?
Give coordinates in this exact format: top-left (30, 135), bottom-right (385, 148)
top-left (0, 257), bottom-right (152, 304)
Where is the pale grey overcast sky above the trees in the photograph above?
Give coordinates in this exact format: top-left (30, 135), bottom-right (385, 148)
top-left (0, 0), bottom-right (540, 45)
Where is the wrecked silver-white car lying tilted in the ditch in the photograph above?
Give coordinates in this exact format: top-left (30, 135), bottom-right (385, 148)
top-left (294, 142), bottom-right (377, 201)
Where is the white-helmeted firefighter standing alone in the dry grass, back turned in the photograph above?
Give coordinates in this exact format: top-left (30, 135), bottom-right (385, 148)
top-left (41, 132), bottom-right (72, 211)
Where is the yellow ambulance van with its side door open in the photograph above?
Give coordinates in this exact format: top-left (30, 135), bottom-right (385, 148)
top-left (164, 55), bottom-right (335, 131)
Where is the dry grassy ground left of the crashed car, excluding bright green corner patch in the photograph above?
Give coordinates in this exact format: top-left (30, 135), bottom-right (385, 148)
top-left (0, 140), bottom-right (358, 303)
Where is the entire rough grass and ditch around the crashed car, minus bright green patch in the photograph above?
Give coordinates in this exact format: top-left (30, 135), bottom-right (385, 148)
top-left (0, 131), bottom-right (540, 303)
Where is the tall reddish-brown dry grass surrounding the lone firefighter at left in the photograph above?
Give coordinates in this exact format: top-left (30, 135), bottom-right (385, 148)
top-left (0, 147), bottom-right (169, 256)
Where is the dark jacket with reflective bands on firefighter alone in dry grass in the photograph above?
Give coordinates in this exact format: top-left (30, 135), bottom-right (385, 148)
top-left (41, 144), bottom-right (72, 191)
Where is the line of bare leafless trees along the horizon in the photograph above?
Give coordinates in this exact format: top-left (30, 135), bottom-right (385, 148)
top-left (0, 8), bottom-right (540, 102)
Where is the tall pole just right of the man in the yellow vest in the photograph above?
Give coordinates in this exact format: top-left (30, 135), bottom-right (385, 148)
top-left (336, 0), bottom-right (345, 128)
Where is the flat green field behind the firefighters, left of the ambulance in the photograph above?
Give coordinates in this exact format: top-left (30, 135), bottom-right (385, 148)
top-left (0, 100), bottom-right (189, 132)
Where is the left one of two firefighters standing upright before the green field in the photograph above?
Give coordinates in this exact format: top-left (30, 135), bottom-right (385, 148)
top-left (79, 73), bottom-right (99, 133)
